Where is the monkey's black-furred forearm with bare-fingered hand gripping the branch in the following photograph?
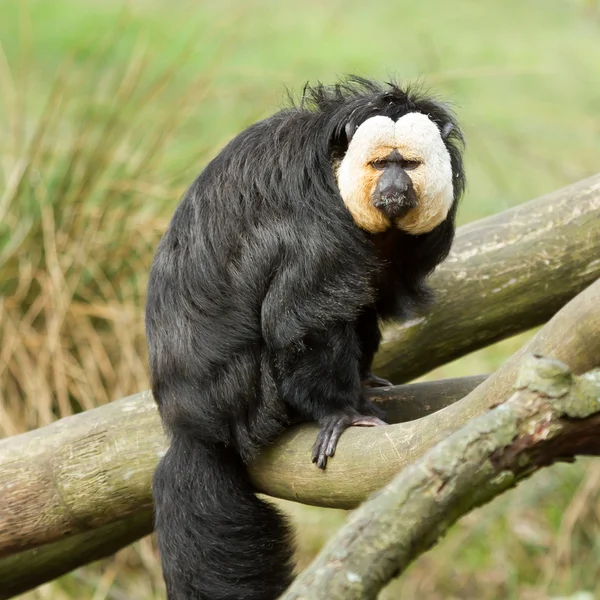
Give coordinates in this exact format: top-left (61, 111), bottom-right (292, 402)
top-left (261, 264), bottom-right (385, 468)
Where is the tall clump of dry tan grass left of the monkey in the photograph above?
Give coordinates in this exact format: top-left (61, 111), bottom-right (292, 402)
top-left (0, 32), bottom-right (211, 435)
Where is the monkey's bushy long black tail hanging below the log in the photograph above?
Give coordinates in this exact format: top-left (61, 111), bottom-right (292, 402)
top-left (153, 434), bottom-right (292, 600)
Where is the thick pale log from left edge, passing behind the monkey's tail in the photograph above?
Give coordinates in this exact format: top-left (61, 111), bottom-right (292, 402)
top-left (0, 376), bottom-right (478, 564)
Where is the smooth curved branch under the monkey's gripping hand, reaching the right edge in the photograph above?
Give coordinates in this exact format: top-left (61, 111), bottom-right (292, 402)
top-left (250, 279), bottom-right (600, 508)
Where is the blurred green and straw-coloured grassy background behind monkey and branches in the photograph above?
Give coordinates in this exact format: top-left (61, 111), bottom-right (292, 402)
top-left (0, 0), bottom-right (600, 600)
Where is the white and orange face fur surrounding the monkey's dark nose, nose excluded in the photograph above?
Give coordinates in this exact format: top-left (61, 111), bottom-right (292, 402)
top-left (336, 113), bottom-right (454, 234)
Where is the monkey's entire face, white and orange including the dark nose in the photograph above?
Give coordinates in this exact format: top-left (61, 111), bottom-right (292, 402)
top-left (334, 112), bottom-right (455, 235)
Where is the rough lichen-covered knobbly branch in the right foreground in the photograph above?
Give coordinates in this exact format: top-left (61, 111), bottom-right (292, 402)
top-left (281, 355), bottom-right (600, 600)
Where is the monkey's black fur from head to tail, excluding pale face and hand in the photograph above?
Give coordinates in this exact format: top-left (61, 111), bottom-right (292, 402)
top-left (146, 78), bottom-right (464, 600)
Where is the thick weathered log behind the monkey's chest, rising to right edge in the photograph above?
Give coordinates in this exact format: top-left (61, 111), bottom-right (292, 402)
top-left (375, 174), bottom-right (600, 383)
